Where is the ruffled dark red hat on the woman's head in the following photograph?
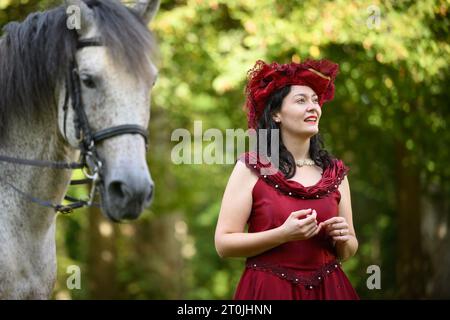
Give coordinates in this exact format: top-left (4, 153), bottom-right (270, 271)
top-left (245, 60), bottom-right (339, 129)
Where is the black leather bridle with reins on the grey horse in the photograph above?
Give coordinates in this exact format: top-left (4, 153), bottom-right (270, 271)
top-left (0, 38), bottom-right (148, 214)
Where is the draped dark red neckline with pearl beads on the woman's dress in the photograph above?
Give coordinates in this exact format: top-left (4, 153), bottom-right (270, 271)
top-left (239, 152), bottom-right (350, 199)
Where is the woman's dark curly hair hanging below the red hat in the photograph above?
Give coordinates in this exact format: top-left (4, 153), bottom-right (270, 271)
top-left (256, 86), bottom-right (335, 179)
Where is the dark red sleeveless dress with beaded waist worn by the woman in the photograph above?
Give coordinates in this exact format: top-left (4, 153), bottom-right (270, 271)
top-left (234, 152), bottom-right (359, 300)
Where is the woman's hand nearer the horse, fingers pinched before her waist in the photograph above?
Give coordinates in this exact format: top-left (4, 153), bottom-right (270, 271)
top-left (280, 209), bottom-right (321, 242)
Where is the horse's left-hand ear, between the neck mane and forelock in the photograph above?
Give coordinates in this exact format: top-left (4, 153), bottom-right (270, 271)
top-left (65, 0), bottom-right (95, 37)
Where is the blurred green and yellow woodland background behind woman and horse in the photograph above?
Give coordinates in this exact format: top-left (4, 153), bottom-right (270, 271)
top-left (0, 0), bottom-right (450, 299)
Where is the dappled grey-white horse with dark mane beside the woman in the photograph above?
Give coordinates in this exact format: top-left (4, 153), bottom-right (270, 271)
top-left (0, 0), bottom-right (159, 299)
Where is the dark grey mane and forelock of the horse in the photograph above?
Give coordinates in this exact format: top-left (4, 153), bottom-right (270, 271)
top-left (0, 0), bottom-right (156, 140)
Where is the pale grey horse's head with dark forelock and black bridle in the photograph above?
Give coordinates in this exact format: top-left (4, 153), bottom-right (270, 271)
top-left (58, 0), bottom-right (159, 221)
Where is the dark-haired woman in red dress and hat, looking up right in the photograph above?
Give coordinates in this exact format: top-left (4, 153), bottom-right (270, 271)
top-left (215, 60), bottom-right (358, 299)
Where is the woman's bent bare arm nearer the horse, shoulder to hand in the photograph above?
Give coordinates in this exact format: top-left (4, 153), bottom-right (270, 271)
top-left (215, 161), bottom-right (320, 257)
